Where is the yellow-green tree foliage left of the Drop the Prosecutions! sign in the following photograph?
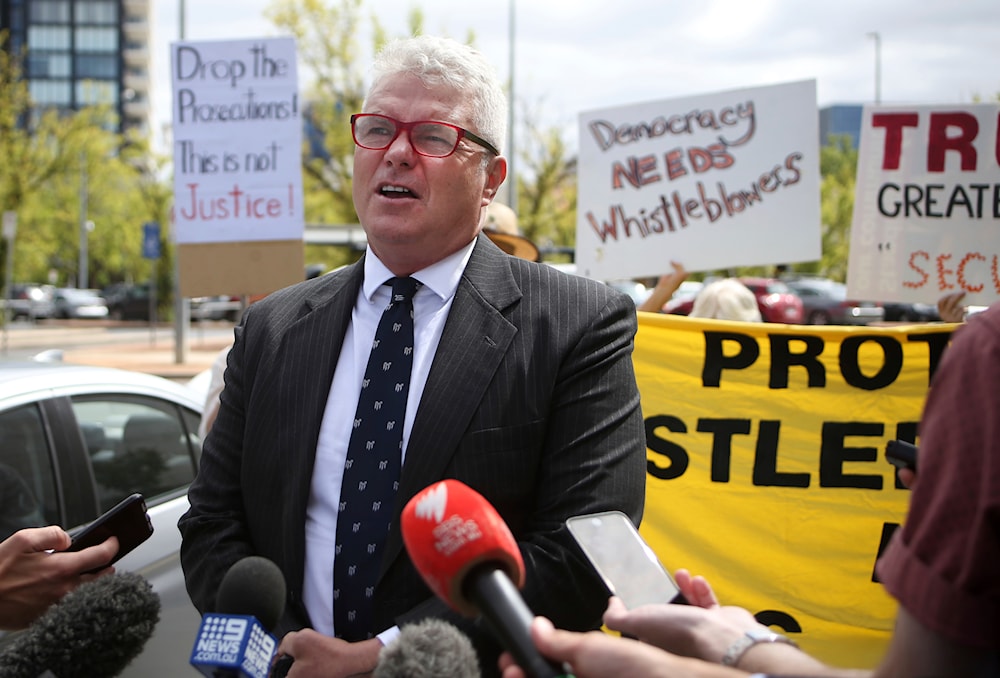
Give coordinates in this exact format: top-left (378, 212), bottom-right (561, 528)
top-left (0, 29), bottom-right (169, 308)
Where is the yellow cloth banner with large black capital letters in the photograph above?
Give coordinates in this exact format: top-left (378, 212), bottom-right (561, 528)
top-left (634, 313), bottom-right (954, 668)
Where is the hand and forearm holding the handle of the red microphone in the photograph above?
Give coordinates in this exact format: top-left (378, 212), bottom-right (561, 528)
top-left (499, 617), bottom-right (746, 678)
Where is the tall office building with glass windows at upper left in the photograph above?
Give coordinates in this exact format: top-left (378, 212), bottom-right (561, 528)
top-left (0, 0), bottom-right (152, 134)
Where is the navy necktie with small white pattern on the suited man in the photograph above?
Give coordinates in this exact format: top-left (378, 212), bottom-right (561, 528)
top-left (333, 278), bottom-right (420, 641)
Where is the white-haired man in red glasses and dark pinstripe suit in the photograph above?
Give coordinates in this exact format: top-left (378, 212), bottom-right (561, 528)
top-left (179, 36), bottom-right (645, 678)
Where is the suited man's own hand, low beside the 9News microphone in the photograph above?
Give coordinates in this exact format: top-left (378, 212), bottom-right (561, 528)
top-left (277, 629), bottom-right (382, 678)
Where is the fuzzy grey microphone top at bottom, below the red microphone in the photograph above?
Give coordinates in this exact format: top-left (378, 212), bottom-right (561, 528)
top-left (372, 619), bottom-right (482, 678)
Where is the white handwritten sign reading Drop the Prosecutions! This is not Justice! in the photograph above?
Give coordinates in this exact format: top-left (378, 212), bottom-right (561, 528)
top-left (171, 38), bottom-right (305, 244)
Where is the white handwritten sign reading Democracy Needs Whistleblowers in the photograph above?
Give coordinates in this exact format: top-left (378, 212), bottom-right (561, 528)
top-left (576, 80), bottom-right (821, 280)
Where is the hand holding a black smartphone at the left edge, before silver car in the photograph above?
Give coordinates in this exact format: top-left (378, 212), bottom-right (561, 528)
top-left (0, 525), bottom-right (118, 631)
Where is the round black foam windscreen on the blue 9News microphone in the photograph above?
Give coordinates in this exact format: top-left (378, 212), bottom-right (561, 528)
top-left (215, 556), bottom-right (286, 631)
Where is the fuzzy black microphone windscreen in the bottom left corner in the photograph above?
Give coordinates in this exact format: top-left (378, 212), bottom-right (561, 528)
top-left (0, 572), bottom-right (160, 678)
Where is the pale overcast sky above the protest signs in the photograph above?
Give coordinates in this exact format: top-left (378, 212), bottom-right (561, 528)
top-left (152, 0), bottom-right (1000, 147)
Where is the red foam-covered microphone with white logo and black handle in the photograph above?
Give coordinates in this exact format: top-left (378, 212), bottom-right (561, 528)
top-left (400, 479), bottom-right (568, 678)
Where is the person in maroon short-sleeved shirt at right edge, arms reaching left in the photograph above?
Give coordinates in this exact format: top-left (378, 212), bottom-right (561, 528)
top-left (502, 304), bottom-right (1000, 678)
